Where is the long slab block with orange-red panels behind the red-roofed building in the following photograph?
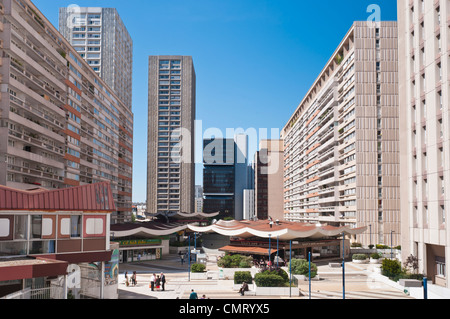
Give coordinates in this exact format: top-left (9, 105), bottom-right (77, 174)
top-left (0, 0), bottom-right (133, 223)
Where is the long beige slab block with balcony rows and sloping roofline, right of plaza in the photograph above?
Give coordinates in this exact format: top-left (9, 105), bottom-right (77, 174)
top-left (281, 22), bottom-right (400, 245)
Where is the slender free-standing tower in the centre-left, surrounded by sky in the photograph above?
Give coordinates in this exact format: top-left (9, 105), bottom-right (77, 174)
top-left (147, 56), bottom-right (196, 214)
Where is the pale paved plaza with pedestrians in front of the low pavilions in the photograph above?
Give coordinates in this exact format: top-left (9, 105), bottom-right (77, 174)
top-left (119, 255), bottom-right (413, 299)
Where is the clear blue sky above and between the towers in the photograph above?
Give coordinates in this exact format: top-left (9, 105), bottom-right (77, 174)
top-left (33, 0), bottom-right (397, 201)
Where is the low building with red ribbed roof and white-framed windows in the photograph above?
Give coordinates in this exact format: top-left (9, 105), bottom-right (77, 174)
top-left (0, 182), bottom-right (119, 299)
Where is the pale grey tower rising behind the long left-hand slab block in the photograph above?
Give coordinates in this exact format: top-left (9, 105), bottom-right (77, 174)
top-left (59, 6), bottom-right (133, 110)
